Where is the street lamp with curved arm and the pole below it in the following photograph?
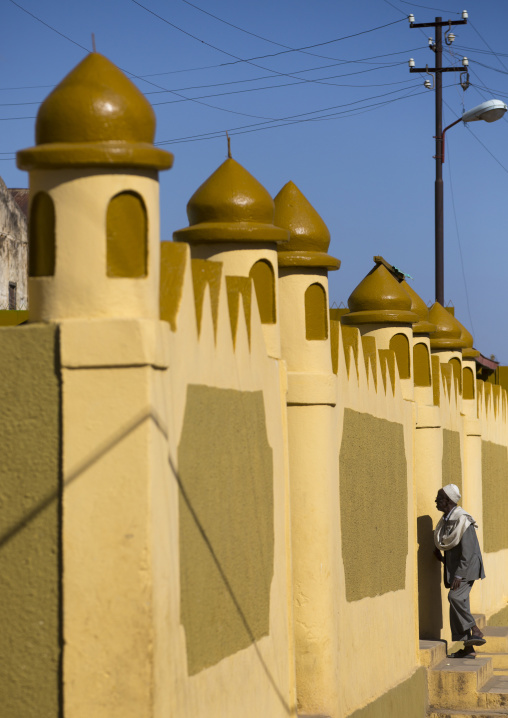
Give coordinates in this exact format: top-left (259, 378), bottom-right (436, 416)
top-left (435, 100), bottom-right (508, 305)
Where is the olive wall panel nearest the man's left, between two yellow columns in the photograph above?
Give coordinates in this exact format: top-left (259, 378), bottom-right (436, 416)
top-left (339, 409), bottom-right (408, 601)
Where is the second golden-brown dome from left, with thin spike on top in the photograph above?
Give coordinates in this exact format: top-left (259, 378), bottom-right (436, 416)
top-left (173, 158), bottom-right (288, 243)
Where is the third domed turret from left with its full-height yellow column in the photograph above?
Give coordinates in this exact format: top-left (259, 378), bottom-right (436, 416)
top-left (275, 182), bottom-right (343, 716)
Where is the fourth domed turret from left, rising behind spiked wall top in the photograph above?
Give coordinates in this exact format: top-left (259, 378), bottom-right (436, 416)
top-left (341, 257), bottom-right (418, 399)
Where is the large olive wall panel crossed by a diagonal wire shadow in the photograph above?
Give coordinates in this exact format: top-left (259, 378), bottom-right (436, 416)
top-left (178, 385), bottom-right (274, 675)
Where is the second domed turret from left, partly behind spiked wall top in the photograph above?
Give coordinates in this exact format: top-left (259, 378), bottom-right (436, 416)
top-left (173, 158), bottom-right (288, 358)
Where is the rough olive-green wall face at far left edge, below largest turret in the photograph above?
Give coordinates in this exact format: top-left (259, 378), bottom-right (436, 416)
top-left (0, 325), bottom-right (62, 718)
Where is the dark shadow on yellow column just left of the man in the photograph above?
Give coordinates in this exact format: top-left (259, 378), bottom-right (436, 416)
top-left (416, 516), bottom-right (443, 640)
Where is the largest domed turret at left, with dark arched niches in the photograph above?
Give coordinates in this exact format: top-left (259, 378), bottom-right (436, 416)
top-left (17, 53), bottom-right (173, 322)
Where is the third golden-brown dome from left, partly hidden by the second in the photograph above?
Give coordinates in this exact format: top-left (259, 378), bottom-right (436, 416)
top-left (274, 182), bottom-right (340, 270)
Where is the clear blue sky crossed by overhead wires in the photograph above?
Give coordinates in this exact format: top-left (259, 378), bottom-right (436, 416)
top-left (0, 0), bottom-right (508, 364)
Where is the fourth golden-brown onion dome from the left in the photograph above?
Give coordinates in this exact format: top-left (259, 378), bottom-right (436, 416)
top-left (342, 264), bottom-right (418, 324)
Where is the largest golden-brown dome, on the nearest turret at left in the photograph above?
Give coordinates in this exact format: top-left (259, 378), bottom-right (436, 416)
top-left (18, 52), bottom-right (173, 169)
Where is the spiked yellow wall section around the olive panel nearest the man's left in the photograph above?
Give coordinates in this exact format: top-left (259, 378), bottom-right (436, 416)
top-left (331, 328), bottom-right (418, 718)
